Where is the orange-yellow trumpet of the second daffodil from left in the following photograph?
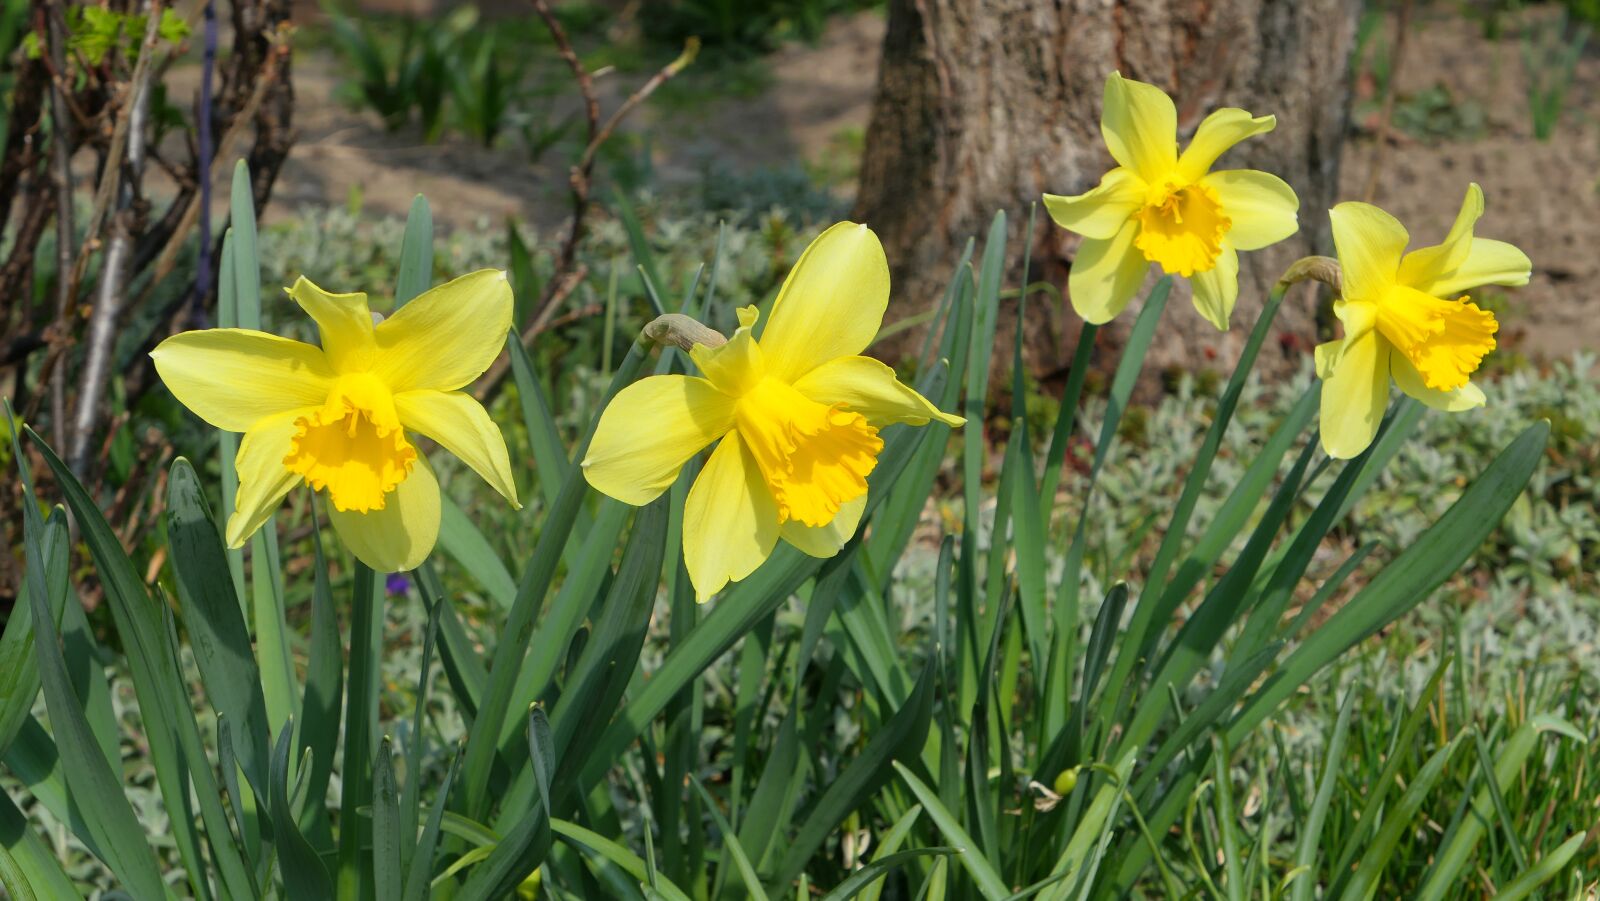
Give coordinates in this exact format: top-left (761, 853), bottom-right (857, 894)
top-left (734, 378), bottom-right (883, 527)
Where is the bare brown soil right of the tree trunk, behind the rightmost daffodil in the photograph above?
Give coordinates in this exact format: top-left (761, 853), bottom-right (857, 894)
top-left (1339, 10), bottom-right (1600, 358)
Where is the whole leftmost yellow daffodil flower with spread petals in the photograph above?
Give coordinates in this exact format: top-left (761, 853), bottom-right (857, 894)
top-left (150, 269), bottom-right (517, 571)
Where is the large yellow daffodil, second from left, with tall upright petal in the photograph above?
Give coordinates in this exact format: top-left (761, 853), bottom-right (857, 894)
top-left (582, 222), bottom-right (963, 602)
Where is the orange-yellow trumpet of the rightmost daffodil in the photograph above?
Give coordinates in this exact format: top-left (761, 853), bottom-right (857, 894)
top-left (1378, 285), bottom-right (1499, 390)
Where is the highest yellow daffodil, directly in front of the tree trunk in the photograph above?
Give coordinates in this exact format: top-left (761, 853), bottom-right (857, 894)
top-left (1045, 72), bottom-right (1299, 331)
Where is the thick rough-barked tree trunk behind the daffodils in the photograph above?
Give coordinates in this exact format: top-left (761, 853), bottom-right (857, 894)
top-left (856, 0), bottom-right (1358, 378)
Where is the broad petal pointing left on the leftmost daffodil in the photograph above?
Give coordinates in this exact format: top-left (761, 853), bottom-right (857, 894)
top-left (150, 328), bottom-right (333, 432)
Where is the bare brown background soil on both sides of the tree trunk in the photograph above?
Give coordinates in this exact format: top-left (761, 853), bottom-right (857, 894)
top-left (274, 6), bottom-right (1600, 358)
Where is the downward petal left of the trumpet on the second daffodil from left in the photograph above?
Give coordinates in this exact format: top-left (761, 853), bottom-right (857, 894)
top-left (683, 432), bottom-right (779, 603)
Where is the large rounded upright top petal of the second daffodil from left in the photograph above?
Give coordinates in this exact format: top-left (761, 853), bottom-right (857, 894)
top-left (762, 222), bottom-right (890, 382)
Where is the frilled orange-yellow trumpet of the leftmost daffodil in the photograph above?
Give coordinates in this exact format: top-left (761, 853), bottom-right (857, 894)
top-left (283, 373), bottom-right (416, 514)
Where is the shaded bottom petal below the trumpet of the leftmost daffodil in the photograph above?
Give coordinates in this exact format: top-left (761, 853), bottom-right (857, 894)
top-left (328, 456), bottom-right (440, 573)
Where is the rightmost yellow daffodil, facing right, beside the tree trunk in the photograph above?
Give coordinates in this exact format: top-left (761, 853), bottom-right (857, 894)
top-left (1317, 184), bottom-right (1533, 459)
